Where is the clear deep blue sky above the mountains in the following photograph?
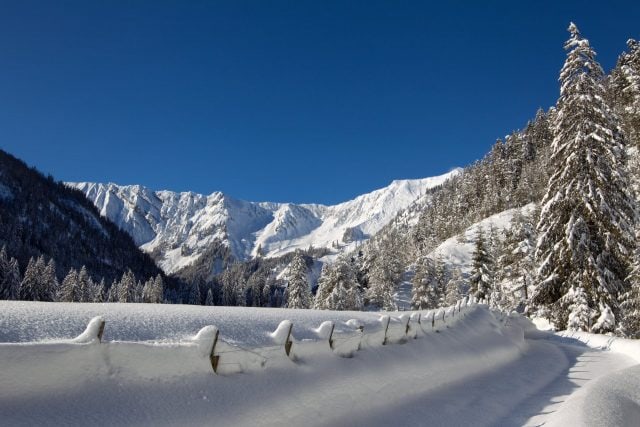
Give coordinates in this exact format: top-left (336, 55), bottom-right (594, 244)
top-left (0, 0), bottom-right (640, 203)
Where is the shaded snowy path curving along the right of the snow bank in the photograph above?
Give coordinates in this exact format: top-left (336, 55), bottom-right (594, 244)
top-left (330, 337), bottom-right (640, 427)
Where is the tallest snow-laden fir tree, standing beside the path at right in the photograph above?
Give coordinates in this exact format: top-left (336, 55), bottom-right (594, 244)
top-left (533, 23), bottom-right (633, 332)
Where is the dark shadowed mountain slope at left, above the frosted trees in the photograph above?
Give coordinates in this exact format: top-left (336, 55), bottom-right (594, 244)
top-left (0, 150), bottom-right (160, 281)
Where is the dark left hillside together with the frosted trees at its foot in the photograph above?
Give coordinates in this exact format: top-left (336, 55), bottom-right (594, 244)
top-left (0, 150), bottom-right (170, 301)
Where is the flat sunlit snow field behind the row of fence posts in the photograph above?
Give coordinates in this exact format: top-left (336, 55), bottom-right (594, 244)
top-left (0, 301), bottom-right (380, 347)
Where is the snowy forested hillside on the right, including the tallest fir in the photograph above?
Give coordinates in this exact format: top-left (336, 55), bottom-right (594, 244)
top-left (350, 24), bottom-right (640, 336)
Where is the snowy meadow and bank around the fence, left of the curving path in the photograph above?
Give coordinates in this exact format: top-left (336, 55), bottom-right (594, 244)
top-left (0, 302), bottom-right (521, 426)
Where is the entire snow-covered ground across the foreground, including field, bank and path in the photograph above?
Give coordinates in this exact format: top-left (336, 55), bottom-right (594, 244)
top-left (0, 301), bottom-right (640, 426)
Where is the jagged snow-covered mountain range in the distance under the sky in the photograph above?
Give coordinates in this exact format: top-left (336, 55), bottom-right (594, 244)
top-left (69, 170), bottom-right (458, 273)
